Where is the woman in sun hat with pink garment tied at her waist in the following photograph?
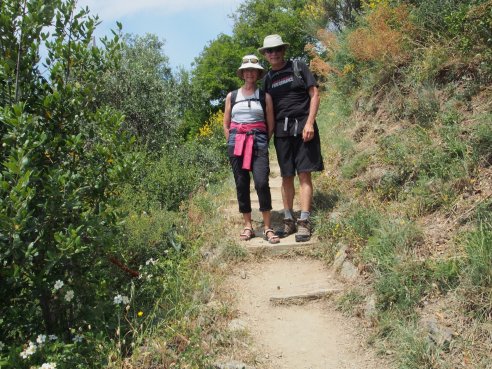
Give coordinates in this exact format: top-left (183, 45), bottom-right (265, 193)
top-left (224, 55), bottom-right (280, 243)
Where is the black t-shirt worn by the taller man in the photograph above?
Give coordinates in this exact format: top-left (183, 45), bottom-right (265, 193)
top-left (263, 60), bottom-right (316, 136)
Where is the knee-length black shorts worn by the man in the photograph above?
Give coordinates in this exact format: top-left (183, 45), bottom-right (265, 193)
top-left (273, 125), bottom-right (324, 177)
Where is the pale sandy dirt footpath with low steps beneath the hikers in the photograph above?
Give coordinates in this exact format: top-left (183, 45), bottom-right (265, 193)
top-left (216, 161), bottom-right (391, 369)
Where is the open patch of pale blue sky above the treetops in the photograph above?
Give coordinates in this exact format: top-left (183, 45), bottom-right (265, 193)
top-left (78, 0), bottom-right (243, 69)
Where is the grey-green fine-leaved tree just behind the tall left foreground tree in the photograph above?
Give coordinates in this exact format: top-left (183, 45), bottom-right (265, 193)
top-left (101, 34), bottom-right (179, 151)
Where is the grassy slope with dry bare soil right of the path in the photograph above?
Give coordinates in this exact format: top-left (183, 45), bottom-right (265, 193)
top-left (315, 66), bottom-right (492, 368)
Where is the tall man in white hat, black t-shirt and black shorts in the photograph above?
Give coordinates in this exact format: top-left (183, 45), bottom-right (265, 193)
top-left (258, 35), bottom-right (324, 242)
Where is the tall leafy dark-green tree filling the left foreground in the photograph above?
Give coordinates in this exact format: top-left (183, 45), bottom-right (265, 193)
top-left (0, 0), bottom-right (132, 368)
